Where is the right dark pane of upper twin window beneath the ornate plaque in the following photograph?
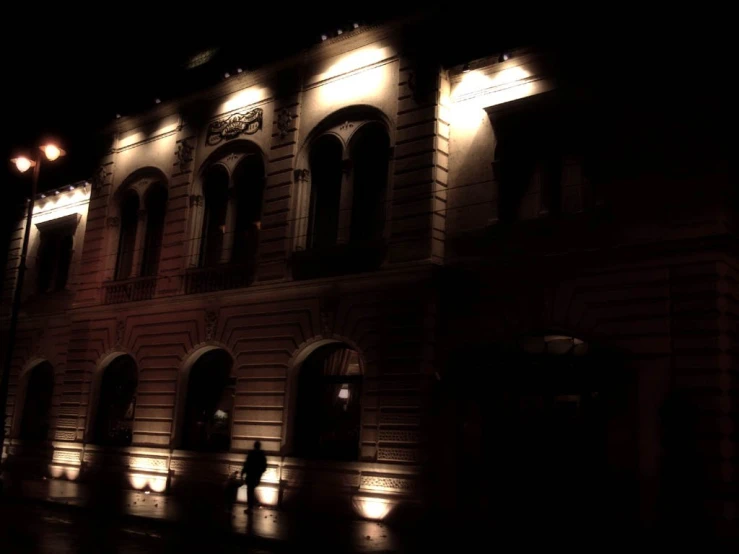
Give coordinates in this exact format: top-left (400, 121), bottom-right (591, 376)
top-left (231, 155), bottom-right (264, 264)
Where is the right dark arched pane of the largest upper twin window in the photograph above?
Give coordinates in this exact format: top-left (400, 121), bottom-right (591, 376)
top-left (350, 123), bottom-right (390, 242)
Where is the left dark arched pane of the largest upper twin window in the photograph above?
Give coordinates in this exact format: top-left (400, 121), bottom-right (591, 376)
top-left (306, 135), bottom-right (342, 248)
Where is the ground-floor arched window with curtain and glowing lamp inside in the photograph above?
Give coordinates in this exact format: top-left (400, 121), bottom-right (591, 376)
top-left (294, 343), bottom-right (362, 460)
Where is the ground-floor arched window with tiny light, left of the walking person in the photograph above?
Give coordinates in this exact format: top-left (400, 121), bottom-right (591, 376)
top-left (182, 349), bottom-right (234, 452)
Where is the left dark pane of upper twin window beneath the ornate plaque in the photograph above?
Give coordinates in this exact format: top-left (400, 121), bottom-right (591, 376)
top-left (200, 165), bottom-right (228, 267)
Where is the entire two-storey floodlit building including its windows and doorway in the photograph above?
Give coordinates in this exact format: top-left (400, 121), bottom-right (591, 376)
top-left (3, 16), bottom-right (739, 532)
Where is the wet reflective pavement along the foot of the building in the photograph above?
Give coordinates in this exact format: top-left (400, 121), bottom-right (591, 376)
top-left (0, 479), bottom-right (408, 554)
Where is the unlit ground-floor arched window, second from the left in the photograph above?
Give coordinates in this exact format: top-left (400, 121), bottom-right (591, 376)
top-left (94, 355), bottom-right (138, 446)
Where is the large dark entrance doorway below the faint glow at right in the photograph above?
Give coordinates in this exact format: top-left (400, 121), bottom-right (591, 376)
top-left (455, 333), bottom-right (617, 531)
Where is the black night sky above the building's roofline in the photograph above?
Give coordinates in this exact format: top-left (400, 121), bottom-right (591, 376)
top-left (0, 0), bottom-right (728, 195)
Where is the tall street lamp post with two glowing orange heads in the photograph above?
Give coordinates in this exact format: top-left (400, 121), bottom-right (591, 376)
top-left (0, 144), bottom-right (64, 459)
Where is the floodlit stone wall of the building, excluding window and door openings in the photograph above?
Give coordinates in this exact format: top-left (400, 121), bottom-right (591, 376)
top-left (3, 15), bottom-right (739, 530)
